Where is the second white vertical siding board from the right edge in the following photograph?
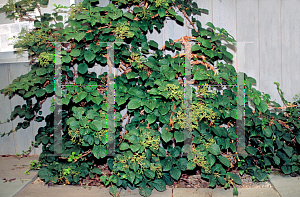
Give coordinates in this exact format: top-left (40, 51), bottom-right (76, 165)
top-left (259, 0), bottom-right (282, 104)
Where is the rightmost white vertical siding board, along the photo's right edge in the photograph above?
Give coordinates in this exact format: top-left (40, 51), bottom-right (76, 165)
top-left (281, 0), bottom-right (300, 101)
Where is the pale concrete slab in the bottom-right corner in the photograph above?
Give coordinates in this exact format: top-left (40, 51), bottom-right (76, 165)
top-left (269, 174), bottom-right (300, 197)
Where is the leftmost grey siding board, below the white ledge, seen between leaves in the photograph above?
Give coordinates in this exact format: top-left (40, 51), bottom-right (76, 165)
top-left (0, 64), bottom-right (15, 155)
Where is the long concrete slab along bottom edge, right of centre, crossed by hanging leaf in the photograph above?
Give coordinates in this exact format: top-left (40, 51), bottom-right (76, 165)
top-left (173, 188), bottom-right (279, 197)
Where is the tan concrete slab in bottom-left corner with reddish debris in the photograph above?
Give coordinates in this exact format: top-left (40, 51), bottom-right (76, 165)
top-left (0, 156), bottom-right (38, 197)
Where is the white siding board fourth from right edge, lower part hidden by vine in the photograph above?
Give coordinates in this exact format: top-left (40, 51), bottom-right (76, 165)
top-left (211, 0), bottom-right (236, 65)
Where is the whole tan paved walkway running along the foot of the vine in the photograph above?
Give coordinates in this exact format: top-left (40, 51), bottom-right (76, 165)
top-left (0, 156), bottom-right (300, 197)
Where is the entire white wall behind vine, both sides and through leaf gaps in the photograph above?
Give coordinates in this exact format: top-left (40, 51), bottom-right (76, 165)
top-left (0, 0), bottom-right (300, 155)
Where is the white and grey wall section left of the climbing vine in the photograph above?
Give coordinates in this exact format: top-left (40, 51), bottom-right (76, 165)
top-left (0, 0), bottom-right (74, 155)
